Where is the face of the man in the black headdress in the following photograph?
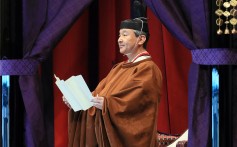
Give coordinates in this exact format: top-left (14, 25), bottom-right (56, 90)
top-left (118, 29), bottom-right (137, 55)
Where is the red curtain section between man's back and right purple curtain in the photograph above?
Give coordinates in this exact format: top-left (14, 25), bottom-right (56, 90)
top-left (147, 9), bottom-right (191, 135)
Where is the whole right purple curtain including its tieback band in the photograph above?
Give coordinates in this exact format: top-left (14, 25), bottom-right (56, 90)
top-left (144, 0), bottom-right (237, 147)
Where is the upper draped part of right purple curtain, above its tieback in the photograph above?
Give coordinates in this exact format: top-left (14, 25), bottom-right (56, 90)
top-left (145, 0), bottom-right (209, 49)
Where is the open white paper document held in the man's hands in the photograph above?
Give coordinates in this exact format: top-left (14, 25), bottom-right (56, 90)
top-left (54, 75), bottom-right (93, 111)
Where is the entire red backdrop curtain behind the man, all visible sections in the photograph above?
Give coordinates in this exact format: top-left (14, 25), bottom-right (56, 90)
top-left (53, 0), bottom-right (191, 147)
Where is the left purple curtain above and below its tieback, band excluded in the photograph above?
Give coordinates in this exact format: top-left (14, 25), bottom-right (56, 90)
top-left (19, 0), bottom-right (92, 147)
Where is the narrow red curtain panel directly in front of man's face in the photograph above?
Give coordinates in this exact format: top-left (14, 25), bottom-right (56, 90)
top-left (98, 0), bottom-right (130, 80)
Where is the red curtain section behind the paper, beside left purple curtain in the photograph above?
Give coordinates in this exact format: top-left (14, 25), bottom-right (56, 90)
top-left (53, 10), bottom-right (89, 147)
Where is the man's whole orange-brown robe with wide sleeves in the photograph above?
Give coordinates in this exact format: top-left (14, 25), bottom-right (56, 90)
top-left (68, 58), bottom-right (162, 147)
